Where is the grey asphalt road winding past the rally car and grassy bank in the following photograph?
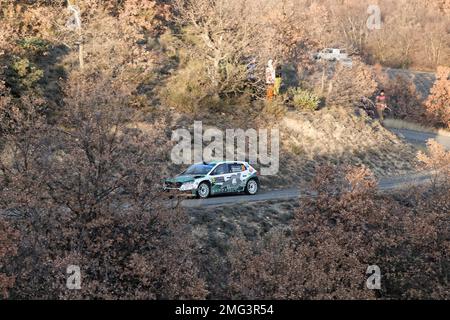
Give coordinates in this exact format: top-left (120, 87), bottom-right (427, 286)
top-left (181, 129), bottom-right (450, 208)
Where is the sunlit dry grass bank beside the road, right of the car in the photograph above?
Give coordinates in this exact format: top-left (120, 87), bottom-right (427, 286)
top-left (262, 108), bottom-right (417, 188)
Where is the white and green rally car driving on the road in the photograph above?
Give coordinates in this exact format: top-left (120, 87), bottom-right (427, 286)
top-left (164, 161), bottom-right (259, 199)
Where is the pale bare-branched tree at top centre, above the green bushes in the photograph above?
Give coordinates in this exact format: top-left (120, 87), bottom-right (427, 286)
top-left (171, 0), bottom-right (258, 93)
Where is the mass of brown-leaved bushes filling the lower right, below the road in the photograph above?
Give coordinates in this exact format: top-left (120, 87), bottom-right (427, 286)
top-left (228, 162), bottom-right (450, 299)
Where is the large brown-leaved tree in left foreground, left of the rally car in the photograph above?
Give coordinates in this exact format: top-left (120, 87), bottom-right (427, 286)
top-left (0, 74), bottom-right (206, 299)
